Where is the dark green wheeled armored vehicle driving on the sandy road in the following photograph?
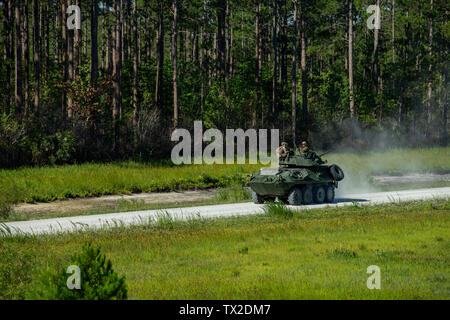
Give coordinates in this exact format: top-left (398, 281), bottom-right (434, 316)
top-left (248, 150), bottom-right (344, 205)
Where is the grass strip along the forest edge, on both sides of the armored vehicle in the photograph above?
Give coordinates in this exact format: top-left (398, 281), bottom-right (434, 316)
top-left (0, 148), bottom-right (450, 203)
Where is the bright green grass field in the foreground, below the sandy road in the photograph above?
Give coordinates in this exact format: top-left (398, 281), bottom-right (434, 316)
top-left (0, 199), bottom-right (450, 299)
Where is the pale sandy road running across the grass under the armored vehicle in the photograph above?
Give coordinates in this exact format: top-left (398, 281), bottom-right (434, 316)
top-left (0, 187), bottom-right (450, 235)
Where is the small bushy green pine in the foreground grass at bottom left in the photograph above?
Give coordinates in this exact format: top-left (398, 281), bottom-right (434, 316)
top-left (33, 243), bottom-right (128, 300)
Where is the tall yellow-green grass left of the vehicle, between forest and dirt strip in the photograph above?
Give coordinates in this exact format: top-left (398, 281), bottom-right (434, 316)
top-left (0, 163), bottom-right (260, 202)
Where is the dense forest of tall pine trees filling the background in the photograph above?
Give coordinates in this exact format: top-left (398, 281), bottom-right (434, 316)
top-left (0, 0), bottom-right (450, 167)
